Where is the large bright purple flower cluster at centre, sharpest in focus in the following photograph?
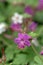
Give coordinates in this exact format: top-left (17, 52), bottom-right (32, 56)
top-left (14, 33), bottom-right (31, 48)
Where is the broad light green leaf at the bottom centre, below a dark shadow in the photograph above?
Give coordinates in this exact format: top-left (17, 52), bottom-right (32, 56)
top-left (13, 54), bottom-right (27, 65)
